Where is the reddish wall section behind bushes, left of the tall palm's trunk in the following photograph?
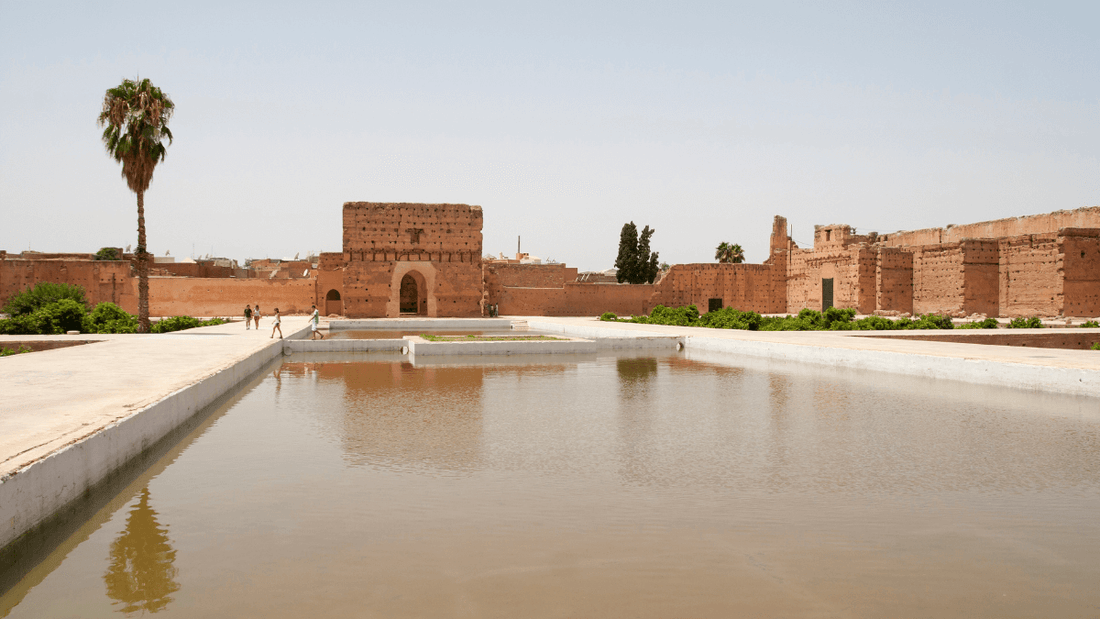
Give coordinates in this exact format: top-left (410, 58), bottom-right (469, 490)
top-left (0, 256), bottom-right (138, 312)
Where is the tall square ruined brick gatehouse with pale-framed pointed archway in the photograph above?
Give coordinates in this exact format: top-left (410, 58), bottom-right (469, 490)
top-left (343, 202), bottom-right (483, 318)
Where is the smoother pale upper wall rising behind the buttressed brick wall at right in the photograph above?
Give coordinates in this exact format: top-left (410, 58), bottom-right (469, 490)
top-left (878, 207), bottom-right (1100, 246)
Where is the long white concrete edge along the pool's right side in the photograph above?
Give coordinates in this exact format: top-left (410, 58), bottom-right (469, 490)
top-left (528, 319), bottom-right (1100, 397)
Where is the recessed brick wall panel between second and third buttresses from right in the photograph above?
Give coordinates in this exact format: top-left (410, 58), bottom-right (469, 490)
top-left (913, 243), bottom-right (965, 316)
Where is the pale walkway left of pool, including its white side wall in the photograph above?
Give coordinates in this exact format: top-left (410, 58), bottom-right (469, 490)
top-left (0, 317), bottom-right (308, 548)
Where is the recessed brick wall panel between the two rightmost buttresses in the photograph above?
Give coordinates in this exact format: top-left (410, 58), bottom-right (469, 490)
top-left (999, 233), bottom-right (1063, 317)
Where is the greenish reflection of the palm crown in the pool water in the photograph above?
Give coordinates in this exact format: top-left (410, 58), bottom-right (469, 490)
top-left (103, 487), bottom-right (179, 614)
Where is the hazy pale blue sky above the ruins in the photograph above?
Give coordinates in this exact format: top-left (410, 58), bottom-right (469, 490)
top-left (0, 0), bottom-right (1100, 269)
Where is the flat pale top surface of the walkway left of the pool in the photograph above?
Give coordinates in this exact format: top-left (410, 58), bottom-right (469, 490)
top-left (0, 317), bottom-right (307, 478)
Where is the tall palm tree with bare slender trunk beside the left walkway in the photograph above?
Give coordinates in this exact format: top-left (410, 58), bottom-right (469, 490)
top-left (97, 78), bottom-right (176, 333)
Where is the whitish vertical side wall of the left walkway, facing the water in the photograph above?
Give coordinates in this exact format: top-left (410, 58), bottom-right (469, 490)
top-left (0, 327), bottom-right (308, 549)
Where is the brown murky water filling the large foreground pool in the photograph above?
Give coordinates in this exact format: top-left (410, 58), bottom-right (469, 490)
top-left (0, 355), bottom-right (1100, 617)
